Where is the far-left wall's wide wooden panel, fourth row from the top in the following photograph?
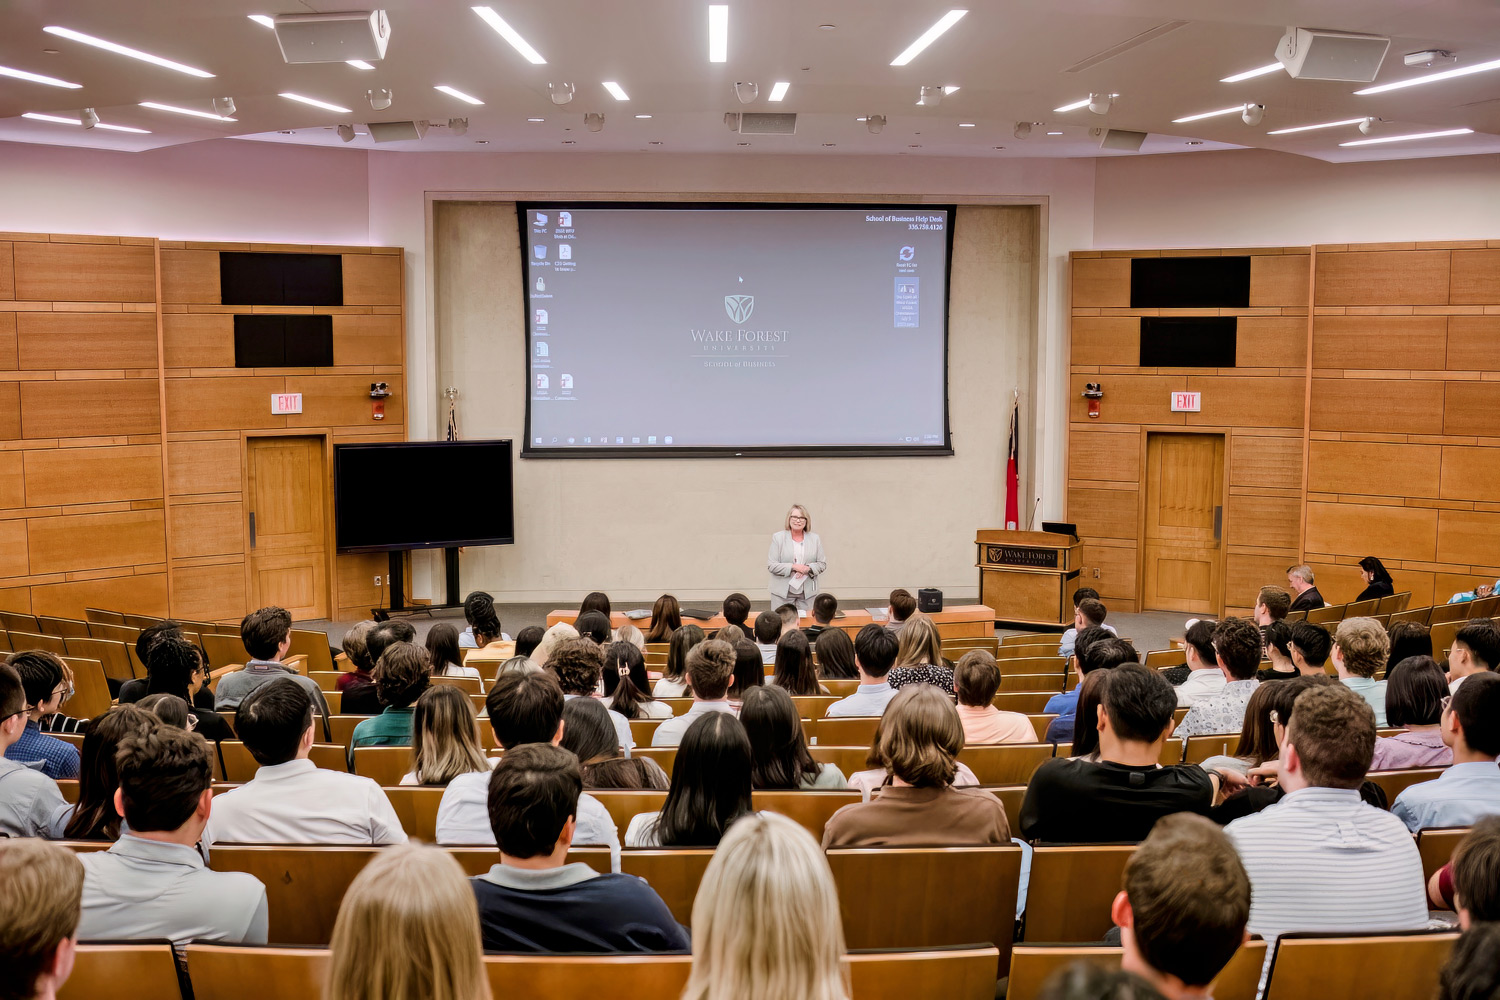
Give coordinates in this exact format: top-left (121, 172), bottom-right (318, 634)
top-left (26, 444), bottom-right (162, 507)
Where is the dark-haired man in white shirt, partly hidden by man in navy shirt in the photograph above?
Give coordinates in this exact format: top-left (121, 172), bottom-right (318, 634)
top-left (437, 672), bottom-right (620, 871)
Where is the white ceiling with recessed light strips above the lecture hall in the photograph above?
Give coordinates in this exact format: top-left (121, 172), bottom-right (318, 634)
top-left (0, 0), bottom-right (1500, 160)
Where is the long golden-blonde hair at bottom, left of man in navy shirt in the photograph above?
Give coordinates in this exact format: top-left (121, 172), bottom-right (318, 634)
top-left (323, 844), bottom-right (491, 1000)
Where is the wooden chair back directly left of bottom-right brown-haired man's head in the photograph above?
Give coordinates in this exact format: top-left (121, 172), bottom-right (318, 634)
top-left (1025, 844), bottom-right (1136, 943)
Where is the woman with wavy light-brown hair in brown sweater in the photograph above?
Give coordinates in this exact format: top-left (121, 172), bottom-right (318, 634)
top-left (824, 684), bottom-right (1011, 850)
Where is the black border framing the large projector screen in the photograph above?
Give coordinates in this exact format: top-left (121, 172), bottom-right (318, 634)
top-left (516, 199), bottom-right (957, 460)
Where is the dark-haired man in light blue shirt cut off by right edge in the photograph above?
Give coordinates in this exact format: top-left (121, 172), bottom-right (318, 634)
top-left (1391, 673), bottom-right (1500, 834)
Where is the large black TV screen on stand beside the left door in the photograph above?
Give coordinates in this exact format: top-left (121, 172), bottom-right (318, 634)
top-left (333, 441), bottom-right (516, 552)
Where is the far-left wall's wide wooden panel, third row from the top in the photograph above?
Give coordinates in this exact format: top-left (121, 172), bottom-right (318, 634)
top-left (21, 378), bottom-right (162, 438)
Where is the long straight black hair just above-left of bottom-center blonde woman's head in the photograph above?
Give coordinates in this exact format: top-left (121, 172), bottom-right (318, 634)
top-left (656, 712), bottom-right (752, 847)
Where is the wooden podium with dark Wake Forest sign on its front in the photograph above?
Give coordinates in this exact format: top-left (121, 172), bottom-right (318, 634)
top-left (974, 529), bottom-right (1083, 627)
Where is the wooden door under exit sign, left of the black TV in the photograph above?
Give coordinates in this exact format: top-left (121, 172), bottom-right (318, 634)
top-left (245, 438), bottom-right (329, 621)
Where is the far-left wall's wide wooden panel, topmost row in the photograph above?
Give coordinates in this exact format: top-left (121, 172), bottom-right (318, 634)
top-left (14, 243), bottom-right (156, 303)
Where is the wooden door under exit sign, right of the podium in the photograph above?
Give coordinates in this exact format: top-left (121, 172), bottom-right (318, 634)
top-left (1142, 433), bottom-right (1224, 615)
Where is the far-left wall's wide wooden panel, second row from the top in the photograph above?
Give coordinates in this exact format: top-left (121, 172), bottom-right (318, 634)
top-left (17, 312), bottom-right (156, 370)
